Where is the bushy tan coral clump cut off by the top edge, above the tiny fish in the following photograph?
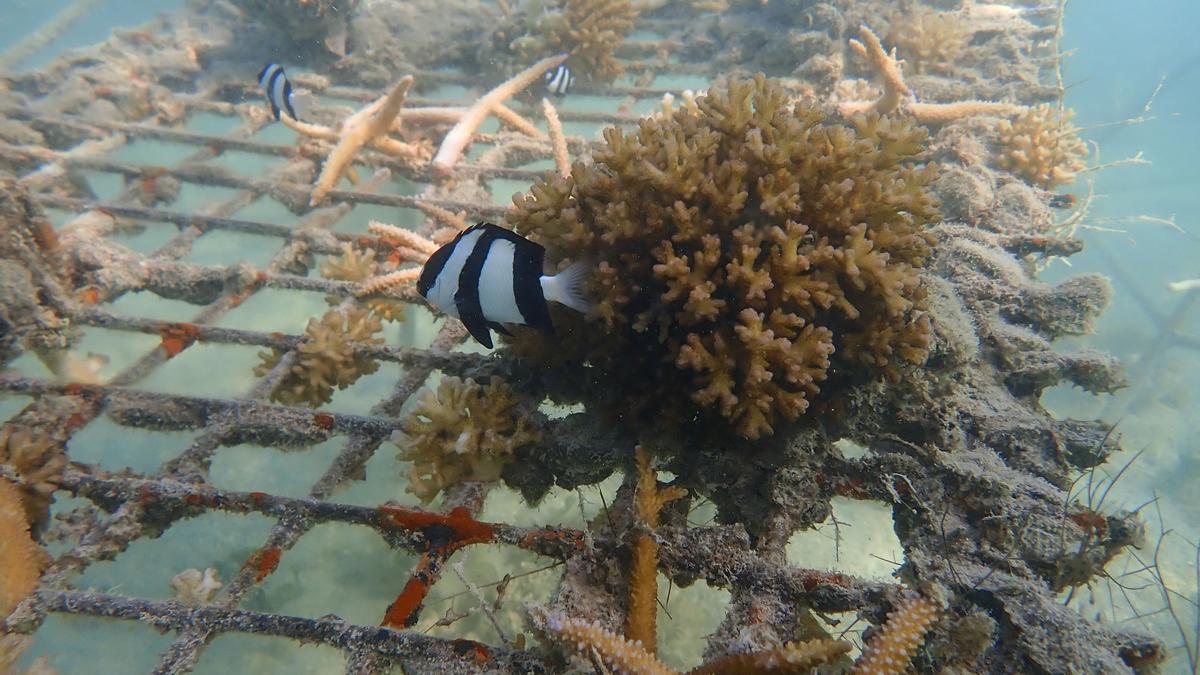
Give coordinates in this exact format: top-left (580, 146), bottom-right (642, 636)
top-left (503, 0), bottom-right (638, 82)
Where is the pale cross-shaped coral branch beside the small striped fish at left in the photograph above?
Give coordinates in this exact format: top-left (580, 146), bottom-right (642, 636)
top-left (280, 76), bottom-right (427, 207)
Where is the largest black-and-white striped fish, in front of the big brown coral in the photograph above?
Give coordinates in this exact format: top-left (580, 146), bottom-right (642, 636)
top-left (416, 222), bottom-right (588, 348)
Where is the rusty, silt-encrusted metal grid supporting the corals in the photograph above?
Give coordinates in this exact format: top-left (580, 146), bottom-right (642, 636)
top-left (0, 1), bottom-right (1171, 673)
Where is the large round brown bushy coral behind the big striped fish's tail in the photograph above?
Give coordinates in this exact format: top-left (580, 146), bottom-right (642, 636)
top-left (509, 76), bottom-right (937, 438)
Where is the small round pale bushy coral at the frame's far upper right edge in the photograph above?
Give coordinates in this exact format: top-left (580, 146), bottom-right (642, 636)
top-left (996, 103), bottom-right (1087, 190)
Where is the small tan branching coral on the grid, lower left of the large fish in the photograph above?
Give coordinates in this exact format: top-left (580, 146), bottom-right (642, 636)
top-left (254, 306), bottom-right (383, 407)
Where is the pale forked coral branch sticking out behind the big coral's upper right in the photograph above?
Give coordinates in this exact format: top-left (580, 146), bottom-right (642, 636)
top-left (838, 25), bottom-right (1024, 124)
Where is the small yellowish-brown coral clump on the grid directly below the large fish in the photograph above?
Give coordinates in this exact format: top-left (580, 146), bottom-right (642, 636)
top-left (396, 377), bottom-right (541, 503)
